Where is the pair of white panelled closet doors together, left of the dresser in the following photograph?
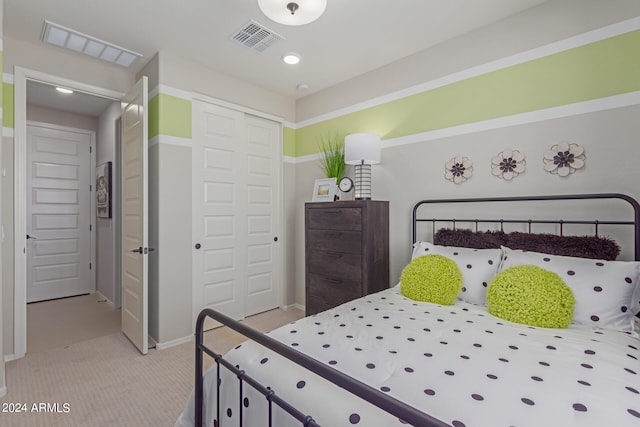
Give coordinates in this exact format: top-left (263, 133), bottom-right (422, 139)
top-left (192, 100), bottom-right (282, 326)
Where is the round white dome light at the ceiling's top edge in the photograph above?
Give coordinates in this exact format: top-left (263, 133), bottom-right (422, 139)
top-left (258, 0), bottom-right (327, 25)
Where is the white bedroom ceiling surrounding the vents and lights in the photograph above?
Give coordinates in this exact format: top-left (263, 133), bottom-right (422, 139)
top-left (4, 0), bottom-right (547, 113)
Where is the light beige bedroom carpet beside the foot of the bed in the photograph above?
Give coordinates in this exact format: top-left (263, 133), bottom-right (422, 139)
top-left (0, 310), bottom-right (303, 427)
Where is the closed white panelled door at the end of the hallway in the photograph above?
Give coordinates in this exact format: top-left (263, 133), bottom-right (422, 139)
top-left (25, 123), bottom-right (95, 302)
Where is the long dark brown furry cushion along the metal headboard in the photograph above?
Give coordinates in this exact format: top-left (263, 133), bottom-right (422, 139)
top-left (433, 228), bottom-right (620, 261)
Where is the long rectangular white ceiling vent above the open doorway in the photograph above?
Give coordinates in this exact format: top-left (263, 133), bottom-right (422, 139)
top-left (40, 21), bottom-right (142, 67)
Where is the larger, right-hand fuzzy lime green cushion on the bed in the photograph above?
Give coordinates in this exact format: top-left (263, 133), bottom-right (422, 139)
top-left (487, 265), bottom-right (576, 328)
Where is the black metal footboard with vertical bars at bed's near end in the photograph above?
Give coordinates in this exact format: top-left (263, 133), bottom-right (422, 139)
top-left (194, 309), bottom-right (448, 427)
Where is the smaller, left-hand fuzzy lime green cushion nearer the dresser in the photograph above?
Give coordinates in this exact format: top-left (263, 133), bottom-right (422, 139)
top-left (400, 255), bottom-right (462, 305)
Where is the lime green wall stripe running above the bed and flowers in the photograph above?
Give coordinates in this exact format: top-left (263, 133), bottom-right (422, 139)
top-left (292, 30), bottom-right (640, 157)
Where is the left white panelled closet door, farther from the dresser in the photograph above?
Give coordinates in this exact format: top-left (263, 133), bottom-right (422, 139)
top-left (192, 100), bottom-right (247, 319)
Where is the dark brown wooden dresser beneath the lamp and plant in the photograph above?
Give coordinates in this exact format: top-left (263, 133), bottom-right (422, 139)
top-left (305, 200), bottom-right (389, 316)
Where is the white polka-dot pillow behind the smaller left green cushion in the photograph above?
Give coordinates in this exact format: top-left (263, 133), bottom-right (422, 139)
top-left (411, 242), bottom-right (502, 305)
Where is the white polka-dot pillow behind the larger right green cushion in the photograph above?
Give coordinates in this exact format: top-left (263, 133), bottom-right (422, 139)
top-left (500, 247), bottom-right (640, 332)
